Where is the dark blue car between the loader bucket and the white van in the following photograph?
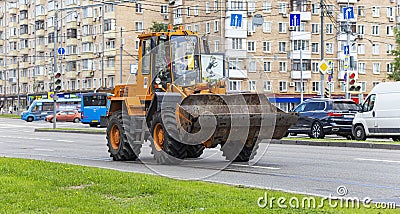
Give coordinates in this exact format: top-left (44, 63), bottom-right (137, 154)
top-left (288, 98), bottom-right (360, 139)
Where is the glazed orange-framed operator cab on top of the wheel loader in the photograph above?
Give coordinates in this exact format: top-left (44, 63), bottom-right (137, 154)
top-left (139, 31), bottom-right (201, 94)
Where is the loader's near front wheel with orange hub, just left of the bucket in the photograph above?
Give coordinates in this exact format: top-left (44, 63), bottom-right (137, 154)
top-left (150, 108), bottom-right (186, 164)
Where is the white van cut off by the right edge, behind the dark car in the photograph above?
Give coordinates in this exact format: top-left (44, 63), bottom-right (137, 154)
top-left (353, 82), bottom-right (400, 141)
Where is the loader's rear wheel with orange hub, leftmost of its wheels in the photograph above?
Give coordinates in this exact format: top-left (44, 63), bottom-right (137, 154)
top-left (107, 111), bottom-right (142, 161)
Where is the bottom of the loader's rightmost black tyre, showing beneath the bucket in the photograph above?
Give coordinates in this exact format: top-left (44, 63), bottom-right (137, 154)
top-left (221, 142), bottom-right (258, 162)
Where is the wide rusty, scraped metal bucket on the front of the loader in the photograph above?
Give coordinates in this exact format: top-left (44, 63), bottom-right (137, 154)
top-left (177, 93), bottom-right (298, 147)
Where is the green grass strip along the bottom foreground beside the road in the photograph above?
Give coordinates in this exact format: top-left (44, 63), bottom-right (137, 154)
top-left (0, 158), bottom-right (394, 213)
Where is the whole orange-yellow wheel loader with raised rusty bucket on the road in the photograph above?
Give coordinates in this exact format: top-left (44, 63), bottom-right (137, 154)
top-left (107, 30), bottom-right (298, 164)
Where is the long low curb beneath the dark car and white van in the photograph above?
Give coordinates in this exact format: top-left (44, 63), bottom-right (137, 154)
top-left (271, 140), bottom-right (400, 150)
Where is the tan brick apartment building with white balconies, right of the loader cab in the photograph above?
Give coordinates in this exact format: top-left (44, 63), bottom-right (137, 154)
top-left (173, 0), bottom-right (399, 110)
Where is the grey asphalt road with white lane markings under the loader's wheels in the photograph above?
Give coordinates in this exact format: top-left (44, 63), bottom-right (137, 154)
top-left (0, 118), bottom-right (400, 205)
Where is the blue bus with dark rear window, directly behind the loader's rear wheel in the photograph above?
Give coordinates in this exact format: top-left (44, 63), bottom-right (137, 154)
top-left (81, 93), bottom-right (109, 127)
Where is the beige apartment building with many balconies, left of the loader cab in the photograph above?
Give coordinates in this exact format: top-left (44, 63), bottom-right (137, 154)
top-left (0, 0), bottom-right (168, 106)
